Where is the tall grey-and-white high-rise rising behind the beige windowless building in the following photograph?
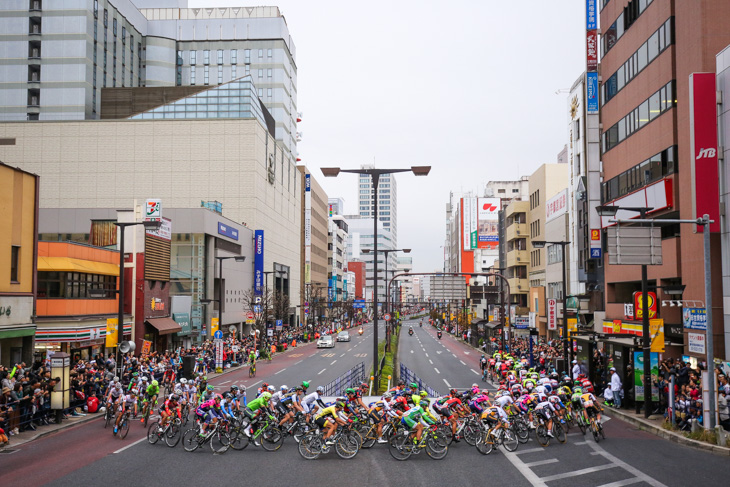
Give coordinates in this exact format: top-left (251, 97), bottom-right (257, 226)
top-left (0, 0), bottom-right (297, 155)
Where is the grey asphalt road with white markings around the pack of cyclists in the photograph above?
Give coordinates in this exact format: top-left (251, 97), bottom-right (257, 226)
top-left (0, 322), bottom-right (728, 487)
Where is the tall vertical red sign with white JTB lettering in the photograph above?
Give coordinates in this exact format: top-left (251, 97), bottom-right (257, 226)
top-left (689, 73), bottom-right (720, 232)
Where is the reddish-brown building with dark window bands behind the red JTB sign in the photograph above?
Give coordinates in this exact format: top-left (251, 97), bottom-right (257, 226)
top-left (590, 0), bottom-right (730, 362)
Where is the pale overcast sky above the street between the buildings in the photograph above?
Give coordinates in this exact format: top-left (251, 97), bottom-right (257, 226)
top-left (189, 0), bottom-right (585, 272)
